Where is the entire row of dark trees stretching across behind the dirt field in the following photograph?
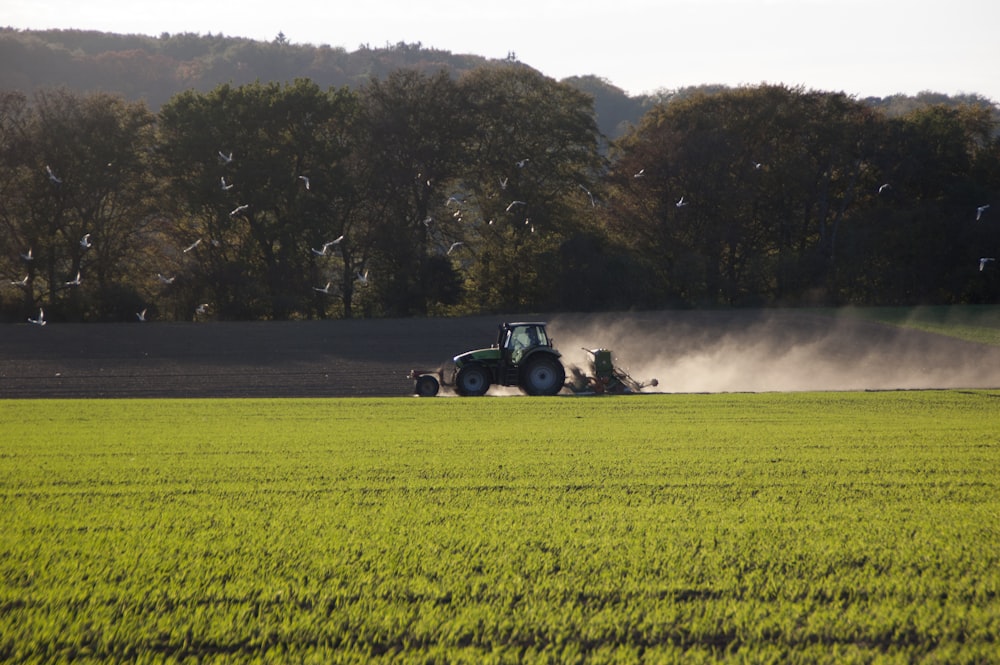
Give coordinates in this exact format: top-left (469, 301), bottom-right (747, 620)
top-left (0, 70), bottom-right (1000, 322)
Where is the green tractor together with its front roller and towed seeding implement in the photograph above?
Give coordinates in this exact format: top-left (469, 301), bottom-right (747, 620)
top-left (407, 321), bottom-right (657, 397)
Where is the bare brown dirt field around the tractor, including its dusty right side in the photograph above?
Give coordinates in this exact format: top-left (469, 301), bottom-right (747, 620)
top-left (0, 310), bottom-right (1000, 399)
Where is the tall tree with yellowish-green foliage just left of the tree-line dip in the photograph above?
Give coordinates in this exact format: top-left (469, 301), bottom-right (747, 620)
top-left (456, 63), bottom-right (606, 311)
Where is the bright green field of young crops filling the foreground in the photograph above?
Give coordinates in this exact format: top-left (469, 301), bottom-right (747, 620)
top-left (0, 391), bottom-right (1000, 663)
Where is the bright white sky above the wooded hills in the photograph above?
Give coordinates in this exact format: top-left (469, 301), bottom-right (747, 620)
top-left (7, 0), bottom-right (1000, 102)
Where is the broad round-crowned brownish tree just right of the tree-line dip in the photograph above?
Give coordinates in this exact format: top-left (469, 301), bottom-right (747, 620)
top-left (608, 86), bottom-right (874, 304)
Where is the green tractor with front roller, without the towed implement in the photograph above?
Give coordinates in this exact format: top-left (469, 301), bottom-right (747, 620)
top-left (408, 321), bottom-right (566, 397)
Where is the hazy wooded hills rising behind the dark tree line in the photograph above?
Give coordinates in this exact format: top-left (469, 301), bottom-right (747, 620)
top-left (0, 28), bottom-right (1000, 139)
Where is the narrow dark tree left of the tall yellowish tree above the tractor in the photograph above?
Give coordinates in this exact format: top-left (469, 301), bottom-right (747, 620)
top-left (355, 70), bottom-right (473, 316)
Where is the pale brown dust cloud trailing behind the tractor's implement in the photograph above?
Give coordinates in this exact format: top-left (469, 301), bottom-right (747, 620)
top-left (549, 310), bottom-right (1000, 392)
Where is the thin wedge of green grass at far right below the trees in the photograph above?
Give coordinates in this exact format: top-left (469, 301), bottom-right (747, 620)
top-left (830, 305), bottom-right (1000, 346)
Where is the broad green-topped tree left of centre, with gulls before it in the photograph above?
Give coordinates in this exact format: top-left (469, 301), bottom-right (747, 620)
top-left (154, 80), bottom-right (355, 319)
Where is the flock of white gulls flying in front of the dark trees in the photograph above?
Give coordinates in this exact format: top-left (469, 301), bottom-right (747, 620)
top-left (10, 158), bottom-right (997, 326)
